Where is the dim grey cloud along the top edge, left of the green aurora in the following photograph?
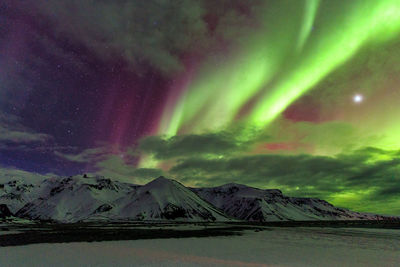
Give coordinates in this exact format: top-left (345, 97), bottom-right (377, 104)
top-left (7, 0), bottom-right (257, 74)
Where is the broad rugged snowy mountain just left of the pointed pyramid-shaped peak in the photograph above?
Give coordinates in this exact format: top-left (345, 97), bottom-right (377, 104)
top-left (16, 176), bottom-right (138, 222)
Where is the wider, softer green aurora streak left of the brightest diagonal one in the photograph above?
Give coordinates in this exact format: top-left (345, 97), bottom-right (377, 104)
top-left (160, 3), bottom-right (303, 135)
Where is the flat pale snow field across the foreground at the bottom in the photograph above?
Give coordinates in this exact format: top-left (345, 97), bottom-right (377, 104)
top-left (0, 227), bottom-right (400, 266)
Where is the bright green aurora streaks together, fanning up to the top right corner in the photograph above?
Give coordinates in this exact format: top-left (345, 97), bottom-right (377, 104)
top-left (158, 0), bottom-right (400, 136)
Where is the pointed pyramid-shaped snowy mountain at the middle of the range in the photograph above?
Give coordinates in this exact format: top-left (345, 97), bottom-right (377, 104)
top-left (101, 177), bottom-right (229, 221)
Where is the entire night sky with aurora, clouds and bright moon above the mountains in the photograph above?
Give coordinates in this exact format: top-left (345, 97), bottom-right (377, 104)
top-left (0, 0), bottom-right (400, 215)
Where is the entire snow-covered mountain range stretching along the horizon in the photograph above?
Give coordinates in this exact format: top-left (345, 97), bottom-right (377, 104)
top-left (0, 176), bottom-right (394, 222)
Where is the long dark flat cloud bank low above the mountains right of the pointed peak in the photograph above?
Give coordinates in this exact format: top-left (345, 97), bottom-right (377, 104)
top-left (171, 155), bottom-right (355, 191)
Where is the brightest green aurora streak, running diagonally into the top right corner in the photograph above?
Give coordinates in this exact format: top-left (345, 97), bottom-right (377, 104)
top-left (251, 1), bottom-right (400, 125)
